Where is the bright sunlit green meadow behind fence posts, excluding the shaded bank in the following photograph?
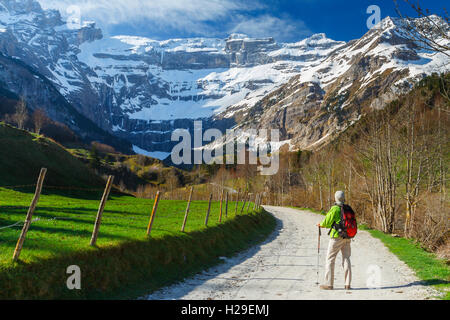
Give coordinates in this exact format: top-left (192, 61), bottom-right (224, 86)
top-left (0, 187), bottom-right (243, 265)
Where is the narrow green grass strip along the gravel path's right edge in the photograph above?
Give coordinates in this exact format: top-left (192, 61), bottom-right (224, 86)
top-left (296, 208), bottom-right (450, 300)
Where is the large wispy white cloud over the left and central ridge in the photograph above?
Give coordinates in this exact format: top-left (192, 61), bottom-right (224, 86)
top-left (38, 0), bottom-right (309, 40)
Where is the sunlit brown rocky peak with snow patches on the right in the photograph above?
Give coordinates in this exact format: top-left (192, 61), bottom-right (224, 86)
top-left (216, 16), bottom-right (450, 150)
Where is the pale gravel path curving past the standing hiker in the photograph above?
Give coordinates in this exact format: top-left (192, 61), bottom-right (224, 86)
top-left (143, 206), bottom-right (437, 300)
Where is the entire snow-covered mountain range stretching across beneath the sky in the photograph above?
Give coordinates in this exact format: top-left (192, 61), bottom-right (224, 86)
top-left (0, 0), bottom-right (449, 155)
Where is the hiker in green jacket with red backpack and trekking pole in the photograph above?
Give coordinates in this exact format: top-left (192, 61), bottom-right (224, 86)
top-left (318, 191), bottom-right (356, 290)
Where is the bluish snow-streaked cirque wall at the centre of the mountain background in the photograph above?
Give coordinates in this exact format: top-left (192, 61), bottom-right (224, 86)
top-left (71, 34), bottom-right (344, 156)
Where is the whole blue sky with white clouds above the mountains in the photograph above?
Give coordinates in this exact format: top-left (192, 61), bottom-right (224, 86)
top-left (39, 0), bottom-right (450, 42)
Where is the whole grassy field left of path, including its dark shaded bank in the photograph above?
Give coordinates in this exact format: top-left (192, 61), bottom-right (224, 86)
top-left (0, 187), bottom-right (275, 299)
